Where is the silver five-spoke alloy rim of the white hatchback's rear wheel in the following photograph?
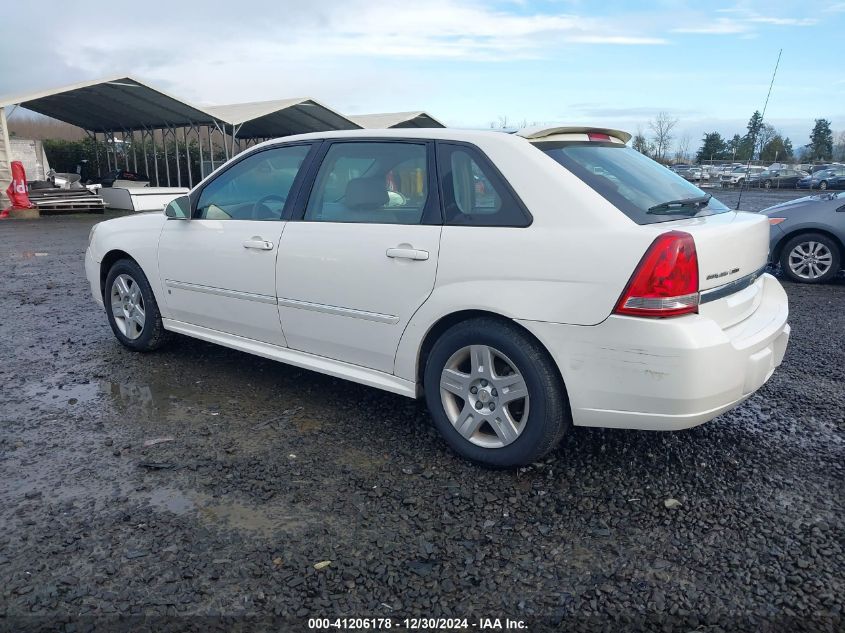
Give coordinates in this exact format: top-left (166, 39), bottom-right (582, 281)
top-left (440, 345), bottom-right (529, 448)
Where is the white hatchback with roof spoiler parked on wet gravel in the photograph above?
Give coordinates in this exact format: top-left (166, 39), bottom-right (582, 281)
top-left (85, 127), bottom-right (789, 466)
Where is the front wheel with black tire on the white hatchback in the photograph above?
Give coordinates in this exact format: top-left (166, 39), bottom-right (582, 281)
top-left (103, 259), bottom-right (167, 352)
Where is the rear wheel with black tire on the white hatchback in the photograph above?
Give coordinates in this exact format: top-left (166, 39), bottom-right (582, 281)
top-left (423, 317), bottom-right (571, 468)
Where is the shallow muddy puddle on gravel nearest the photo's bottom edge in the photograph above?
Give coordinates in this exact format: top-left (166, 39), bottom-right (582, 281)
top-left (150, 488), bottom-right (301, 536)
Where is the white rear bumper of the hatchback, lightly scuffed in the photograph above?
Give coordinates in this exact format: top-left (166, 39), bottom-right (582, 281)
top-left (520, 275), bottom-right (790, 431)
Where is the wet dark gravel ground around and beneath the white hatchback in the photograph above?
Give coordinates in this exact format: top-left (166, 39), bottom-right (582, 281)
top-left (0, 193), bottom-right (845, 632)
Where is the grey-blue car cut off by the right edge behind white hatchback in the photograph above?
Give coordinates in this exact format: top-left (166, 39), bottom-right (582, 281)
top-left (761, 191), bottom-right (845, 283)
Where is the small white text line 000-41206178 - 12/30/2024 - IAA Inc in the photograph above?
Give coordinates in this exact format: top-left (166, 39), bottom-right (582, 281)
top-left (308, 618), bottom-right (528, 631)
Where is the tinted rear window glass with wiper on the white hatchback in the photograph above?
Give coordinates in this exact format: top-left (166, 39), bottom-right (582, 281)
top-left (537, 142), bottom-right (730, 224)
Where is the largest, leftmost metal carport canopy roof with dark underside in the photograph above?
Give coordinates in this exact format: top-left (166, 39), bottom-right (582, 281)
top-left (0, 76), bottom-right (217, 132)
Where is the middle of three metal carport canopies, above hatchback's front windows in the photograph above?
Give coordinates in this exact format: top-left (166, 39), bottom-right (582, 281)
top-left (205, 98), bottom-right (361, 139)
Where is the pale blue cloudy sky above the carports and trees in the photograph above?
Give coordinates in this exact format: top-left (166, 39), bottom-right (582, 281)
top-left (0, 0), bottom-right (845, 147)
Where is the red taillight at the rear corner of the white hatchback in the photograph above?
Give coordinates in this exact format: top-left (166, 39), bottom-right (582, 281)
top-left (614, 231), bottom-right (699, 317)
